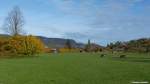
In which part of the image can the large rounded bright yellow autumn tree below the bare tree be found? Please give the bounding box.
[10,35,44,55]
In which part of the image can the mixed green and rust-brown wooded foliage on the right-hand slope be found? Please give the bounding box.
[107,38,150,52]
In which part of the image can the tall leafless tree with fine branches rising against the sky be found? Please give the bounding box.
[3,6,24,36]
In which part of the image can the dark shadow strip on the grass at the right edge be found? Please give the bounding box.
[113,57,150,63]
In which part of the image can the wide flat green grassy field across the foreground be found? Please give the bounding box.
[0,53,150,84]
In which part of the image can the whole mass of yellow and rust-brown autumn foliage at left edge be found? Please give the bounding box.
[0,35,44,55]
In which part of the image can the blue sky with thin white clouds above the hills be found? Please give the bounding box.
[0,0,150,45]
